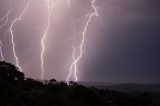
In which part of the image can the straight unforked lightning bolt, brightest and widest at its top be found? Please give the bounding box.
[41,0,54,79]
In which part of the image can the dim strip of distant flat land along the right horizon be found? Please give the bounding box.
[78,82,160,93]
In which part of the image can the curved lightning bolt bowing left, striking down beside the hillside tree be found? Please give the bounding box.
[9,0,33,72]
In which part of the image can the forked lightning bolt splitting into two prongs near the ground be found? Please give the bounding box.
[66,0,98,84]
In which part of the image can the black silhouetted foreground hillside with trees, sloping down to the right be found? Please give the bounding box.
[0,62,160,106]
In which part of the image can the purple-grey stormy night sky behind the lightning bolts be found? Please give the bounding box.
[0,0,160,83]
